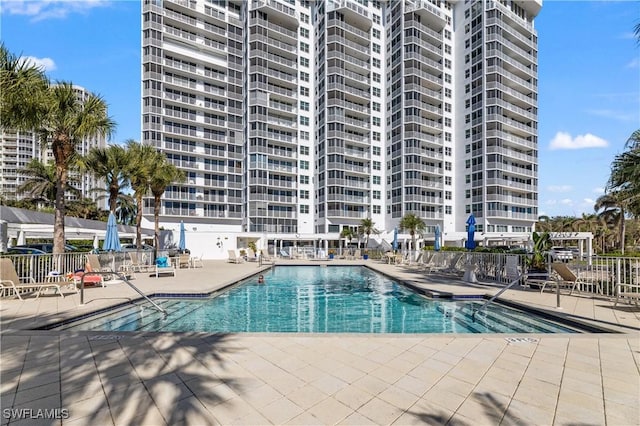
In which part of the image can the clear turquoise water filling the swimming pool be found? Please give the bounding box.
[57,266,578,333]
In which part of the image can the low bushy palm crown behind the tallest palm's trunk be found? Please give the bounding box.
[16,158,80,207]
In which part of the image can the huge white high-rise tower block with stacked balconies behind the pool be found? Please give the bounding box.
[142,0,542,246]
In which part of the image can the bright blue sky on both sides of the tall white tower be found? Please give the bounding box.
[0,0,640,216]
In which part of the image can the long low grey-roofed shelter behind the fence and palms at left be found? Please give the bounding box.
[0,206,154,252]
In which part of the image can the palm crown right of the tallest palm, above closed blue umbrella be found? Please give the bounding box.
[84,145,130,214]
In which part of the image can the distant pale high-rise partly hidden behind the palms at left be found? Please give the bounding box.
[0,86,106,205]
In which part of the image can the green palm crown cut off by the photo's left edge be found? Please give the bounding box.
[0,43,49,130]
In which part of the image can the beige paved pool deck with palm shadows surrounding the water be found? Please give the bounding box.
[0,260,640,426]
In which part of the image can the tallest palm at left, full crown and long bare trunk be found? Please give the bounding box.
[38,82,115,254]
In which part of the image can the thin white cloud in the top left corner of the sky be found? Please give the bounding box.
[0,0,111,22]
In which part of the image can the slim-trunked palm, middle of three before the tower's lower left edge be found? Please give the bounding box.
[126,139,158,248]
